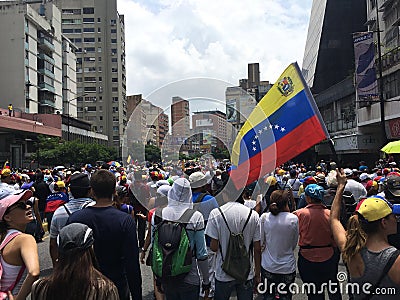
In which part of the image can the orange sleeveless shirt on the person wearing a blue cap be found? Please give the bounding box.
[293,203,336,262]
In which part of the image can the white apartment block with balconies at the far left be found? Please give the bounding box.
[0,1,77,117]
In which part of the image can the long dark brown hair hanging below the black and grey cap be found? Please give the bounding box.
[37,247,112,300]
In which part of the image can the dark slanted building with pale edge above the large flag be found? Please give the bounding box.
[302,0,366,94]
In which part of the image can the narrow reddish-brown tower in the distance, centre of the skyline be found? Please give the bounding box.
[171,97,190,139]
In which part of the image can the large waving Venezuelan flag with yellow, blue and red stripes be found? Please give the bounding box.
[230,63,329,189]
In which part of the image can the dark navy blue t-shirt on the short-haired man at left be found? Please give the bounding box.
[67,206,142,299]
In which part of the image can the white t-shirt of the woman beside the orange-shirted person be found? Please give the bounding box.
[260,212,299,274]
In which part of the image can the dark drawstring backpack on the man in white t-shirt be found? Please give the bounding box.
[218,207,253,282]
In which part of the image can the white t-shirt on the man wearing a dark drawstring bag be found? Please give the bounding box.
[206,202,260,282]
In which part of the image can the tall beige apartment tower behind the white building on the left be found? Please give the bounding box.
[53,0,127,147]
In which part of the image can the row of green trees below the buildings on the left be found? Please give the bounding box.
[31,136,118,166]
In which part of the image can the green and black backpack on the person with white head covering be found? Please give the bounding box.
[151,208,195,283]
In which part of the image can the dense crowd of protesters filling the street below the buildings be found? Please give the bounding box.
[0,159,400,300]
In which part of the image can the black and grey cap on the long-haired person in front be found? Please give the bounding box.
[57,223,94,253]
